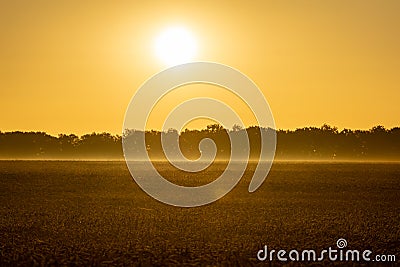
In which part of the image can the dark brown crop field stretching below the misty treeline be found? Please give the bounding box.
[0,161,400,266]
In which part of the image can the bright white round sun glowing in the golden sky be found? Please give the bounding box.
[154,27,197,66]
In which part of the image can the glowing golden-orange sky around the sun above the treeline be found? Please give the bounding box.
[0,0,400,134]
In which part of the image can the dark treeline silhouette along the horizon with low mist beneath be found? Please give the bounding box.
[0,124,400,160]
